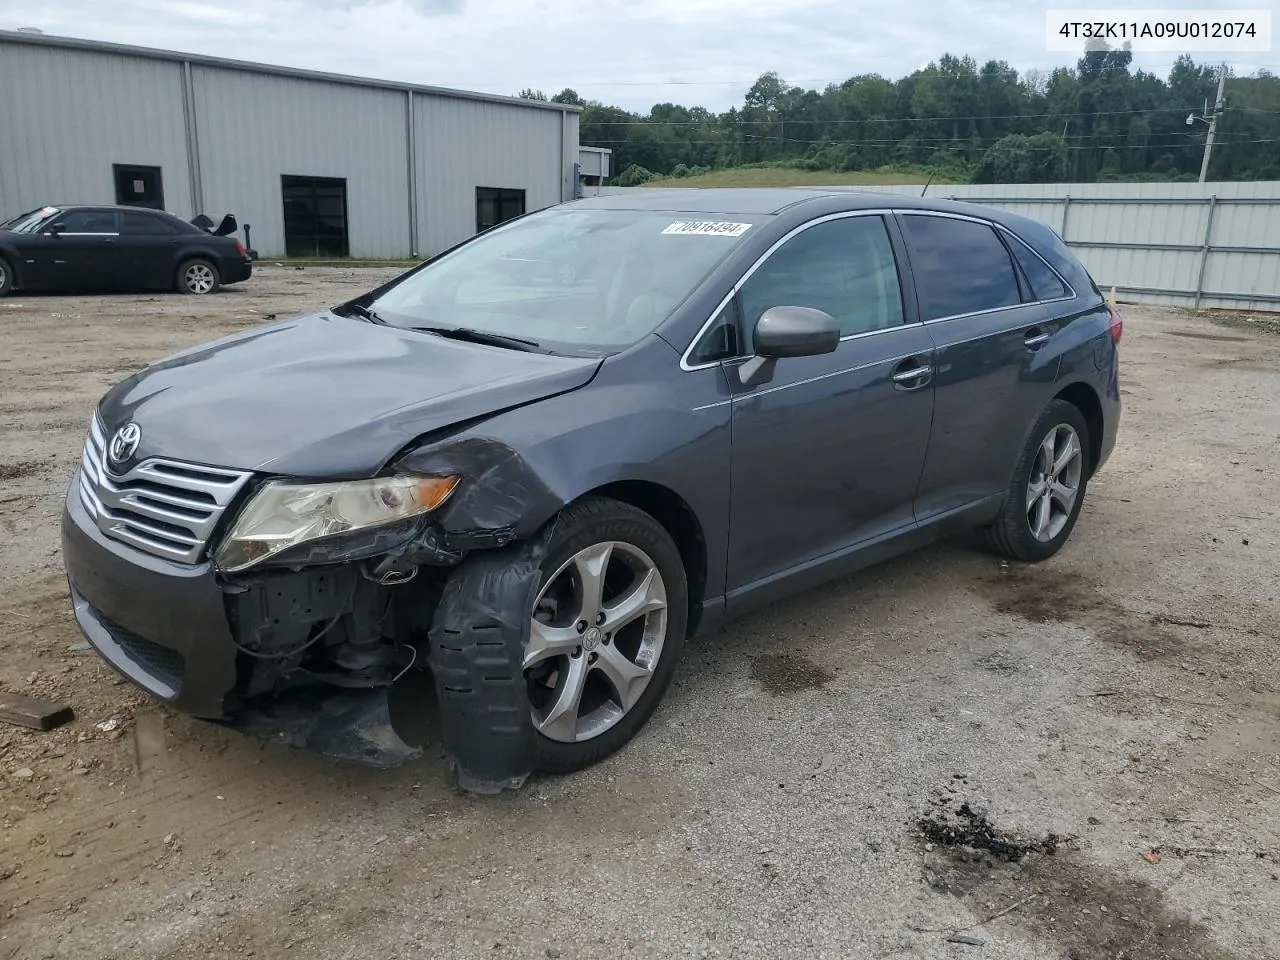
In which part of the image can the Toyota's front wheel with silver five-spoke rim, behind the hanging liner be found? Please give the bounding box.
[524,498,689,772]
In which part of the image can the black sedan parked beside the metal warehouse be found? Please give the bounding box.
[0,206,253,297]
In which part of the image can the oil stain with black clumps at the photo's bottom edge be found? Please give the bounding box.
[916,799,1230,960]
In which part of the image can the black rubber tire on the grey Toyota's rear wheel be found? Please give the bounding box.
[980,399,1093,563]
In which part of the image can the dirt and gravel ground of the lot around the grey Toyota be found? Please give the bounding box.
[0,266,1280,960]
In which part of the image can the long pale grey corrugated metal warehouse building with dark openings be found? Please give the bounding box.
[0,31,580,257]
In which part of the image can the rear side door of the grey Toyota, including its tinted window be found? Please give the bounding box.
[897,211,1057,524]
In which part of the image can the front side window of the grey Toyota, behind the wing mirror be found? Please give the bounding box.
[739,216,902,337]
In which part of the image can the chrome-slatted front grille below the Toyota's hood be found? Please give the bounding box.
[79,416,250,563]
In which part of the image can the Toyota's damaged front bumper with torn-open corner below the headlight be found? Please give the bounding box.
[61,480,425,767]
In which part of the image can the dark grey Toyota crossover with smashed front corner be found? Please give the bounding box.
[63,189,1121,790]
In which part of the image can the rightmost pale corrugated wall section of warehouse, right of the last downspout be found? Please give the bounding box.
[413,96,577,256]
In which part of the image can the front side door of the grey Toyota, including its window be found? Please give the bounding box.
[726,214,933,596]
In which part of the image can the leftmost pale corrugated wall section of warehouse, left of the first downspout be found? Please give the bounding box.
[0,41,191,218]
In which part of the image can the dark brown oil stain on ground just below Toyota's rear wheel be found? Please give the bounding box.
[977,567,1184,659]
